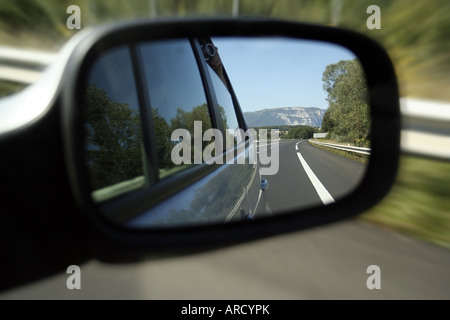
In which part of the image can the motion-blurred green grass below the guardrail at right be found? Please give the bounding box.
[361,156,450,248]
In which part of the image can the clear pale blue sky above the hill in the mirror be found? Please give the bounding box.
[212,38,355,112]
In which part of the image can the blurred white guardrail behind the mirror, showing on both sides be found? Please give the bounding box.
[0,46,450,159]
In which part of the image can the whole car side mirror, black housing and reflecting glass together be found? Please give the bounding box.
[62,19,400,260]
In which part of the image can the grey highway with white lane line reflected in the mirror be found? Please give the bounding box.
[260,140,366,213]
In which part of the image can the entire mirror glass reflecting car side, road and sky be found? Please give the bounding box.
[82,37,371,228]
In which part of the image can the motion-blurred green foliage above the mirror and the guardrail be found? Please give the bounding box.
[0,0,450,100]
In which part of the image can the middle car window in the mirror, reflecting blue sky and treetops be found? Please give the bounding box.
[139,39,212,179]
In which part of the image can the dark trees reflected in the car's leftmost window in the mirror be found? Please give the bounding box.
[85,85,143,190]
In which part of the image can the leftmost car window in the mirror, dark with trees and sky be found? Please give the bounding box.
[84,46,146,201]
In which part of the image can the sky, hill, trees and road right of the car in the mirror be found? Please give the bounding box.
[213,38,370,213]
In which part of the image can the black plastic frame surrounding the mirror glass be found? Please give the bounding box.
[61,18,401,262]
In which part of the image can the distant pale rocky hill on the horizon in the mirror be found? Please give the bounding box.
[244,107,326,127]
